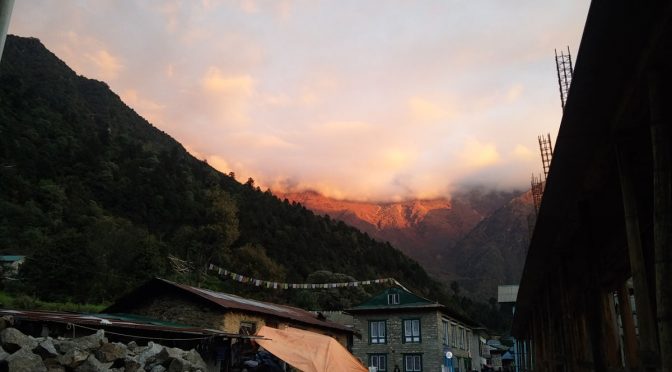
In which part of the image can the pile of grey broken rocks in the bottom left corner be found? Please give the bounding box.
[0,328,207,372]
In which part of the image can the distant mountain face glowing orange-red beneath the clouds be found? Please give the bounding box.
[275,187,532,297]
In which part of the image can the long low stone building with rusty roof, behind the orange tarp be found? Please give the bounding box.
[104,278,353,347]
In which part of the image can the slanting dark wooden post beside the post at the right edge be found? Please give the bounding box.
[617,148,658,370]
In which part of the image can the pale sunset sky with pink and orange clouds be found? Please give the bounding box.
[9,0,589,201]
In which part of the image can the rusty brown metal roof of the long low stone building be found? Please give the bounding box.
[104,278,353,332]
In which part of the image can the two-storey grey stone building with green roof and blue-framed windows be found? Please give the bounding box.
[347,288,482,372]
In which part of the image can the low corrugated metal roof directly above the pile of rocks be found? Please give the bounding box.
[0,309,250,338]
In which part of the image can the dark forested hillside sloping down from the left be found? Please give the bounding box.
[0,36,510,332]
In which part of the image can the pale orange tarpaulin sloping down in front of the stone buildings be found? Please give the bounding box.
[255,326,368,372]
